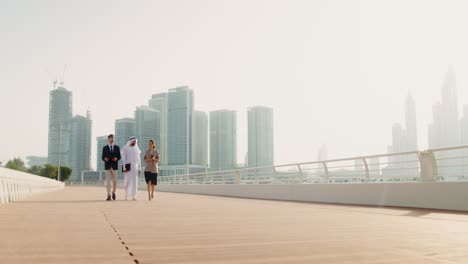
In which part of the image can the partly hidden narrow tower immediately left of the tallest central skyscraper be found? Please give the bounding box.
[148,93,167,165]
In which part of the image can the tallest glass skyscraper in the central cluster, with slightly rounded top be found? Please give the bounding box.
[167,86,194,165]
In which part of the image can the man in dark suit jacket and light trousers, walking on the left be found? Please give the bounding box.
[102,134,120,201]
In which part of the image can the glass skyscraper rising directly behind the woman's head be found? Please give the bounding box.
[135,106,160,160]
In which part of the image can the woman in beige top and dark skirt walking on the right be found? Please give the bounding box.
[144,139,159,201]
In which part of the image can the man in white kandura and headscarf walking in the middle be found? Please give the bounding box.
[121,137,141,201]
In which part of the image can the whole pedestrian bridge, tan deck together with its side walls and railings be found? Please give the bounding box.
[0,146,468,263]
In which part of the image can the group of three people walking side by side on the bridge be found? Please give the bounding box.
[102,134,160,201]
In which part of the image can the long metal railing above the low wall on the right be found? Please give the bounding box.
[77,145,468,188]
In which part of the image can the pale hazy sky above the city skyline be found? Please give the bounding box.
[0,0,468,168]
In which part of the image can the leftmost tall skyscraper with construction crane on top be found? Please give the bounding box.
[48,86,72,166]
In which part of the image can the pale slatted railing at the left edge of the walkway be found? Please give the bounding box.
[0,167,64,204]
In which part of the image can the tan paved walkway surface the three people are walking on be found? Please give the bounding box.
[0,187,468,264]
